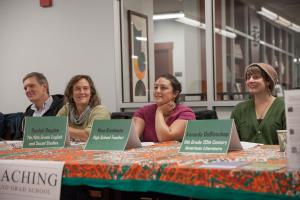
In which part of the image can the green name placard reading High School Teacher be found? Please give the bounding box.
[85,119,141,151]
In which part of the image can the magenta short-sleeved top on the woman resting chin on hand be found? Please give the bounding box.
[134,104,196,142]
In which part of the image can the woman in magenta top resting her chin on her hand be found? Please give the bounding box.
[133,74,196,142]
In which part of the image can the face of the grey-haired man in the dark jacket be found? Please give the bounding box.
[23,76,48,104]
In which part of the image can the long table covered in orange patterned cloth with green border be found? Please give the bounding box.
[0,142,300,200]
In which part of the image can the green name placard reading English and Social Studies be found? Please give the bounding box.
[23,116,68,148]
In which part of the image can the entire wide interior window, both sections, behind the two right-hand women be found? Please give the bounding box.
[120,0,300,109]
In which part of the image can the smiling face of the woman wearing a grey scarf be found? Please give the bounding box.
[72,78,91,107]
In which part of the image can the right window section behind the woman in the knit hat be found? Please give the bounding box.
[214,0,296,101]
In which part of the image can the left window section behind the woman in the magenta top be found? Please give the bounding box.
[122,0,207,102]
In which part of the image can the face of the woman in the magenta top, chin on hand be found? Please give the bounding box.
[153,78,176,106]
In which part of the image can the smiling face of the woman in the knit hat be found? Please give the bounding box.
[246,67,270,95]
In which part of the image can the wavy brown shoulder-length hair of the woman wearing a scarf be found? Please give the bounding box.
[64,74,101,108]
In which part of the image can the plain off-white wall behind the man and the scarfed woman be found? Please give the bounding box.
[0,0,119,113]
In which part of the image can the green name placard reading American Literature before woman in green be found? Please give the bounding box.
[179,119,242,153]
